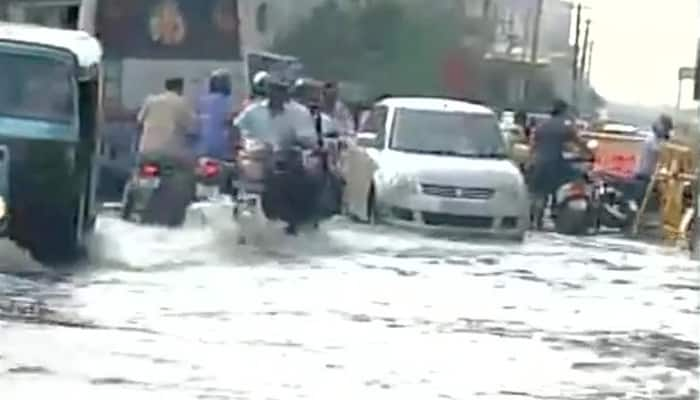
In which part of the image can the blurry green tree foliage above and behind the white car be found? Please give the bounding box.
[274,0,462,99]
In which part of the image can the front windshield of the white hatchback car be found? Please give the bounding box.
[391,109,507,158]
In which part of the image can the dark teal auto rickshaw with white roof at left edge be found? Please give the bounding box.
[0,23,102,262]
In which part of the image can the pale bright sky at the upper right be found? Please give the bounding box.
[582,0,700,107]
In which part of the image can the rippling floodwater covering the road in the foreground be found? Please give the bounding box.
[0,206,700,400]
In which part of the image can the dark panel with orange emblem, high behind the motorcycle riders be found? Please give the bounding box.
[96,0,241,60]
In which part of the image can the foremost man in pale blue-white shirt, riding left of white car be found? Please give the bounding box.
[234,76,320,234]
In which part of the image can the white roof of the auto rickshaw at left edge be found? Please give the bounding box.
[0,22,102,67]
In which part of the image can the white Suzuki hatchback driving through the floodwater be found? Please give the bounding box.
[343,98,530,240]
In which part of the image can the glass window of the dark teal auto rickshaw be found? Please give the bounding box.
[0,50,76,125]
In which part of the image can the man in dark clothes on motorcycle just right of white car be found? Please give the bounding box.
[529,100,592,229]
